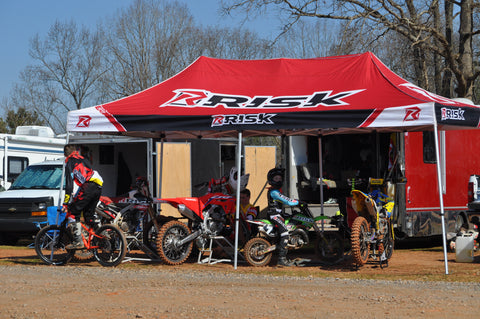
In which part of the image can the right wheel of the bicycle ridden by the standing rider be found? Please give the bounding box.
[92,225,127,267]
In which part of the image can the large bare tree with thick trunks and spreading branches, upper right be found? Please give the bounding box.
[222,0,480,98]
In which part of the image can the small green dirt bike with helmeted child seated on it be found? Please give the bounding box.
[244,203,343,267]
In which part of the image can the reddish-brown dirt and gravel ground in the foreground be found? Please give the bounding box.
[0,246,480,318]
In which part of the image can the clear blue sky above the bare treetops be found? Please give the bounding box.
[0,0,276,99]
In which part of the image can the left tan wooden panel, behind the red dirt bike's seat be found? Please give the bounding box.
[156,142,192,217]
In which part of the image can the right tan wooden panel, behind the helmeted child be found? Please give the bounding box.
[245,146,276,210]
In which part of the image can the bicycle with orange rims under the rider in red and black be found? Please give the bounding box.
[35,208,127,266]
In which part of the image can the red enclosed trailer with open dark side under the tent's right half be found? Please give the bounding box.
[289,130,480,239]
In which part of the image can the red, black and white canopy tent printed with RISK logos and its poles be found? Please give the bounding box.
[67,52,480,272]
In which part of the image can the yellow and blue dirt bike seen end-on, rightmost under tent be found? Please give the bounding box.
[351,179,395,268]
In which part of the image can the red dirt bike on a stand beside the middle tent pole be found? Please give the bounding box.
[157,170,249,265]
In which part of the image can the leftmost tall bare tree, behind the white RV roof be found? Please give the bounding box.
[5,21,104,132]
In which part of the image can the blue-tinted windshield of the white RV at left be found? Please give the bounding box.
[10,165,62,189]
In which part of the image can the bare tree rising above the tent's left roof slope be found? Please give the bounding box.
[99,0,198,99]
